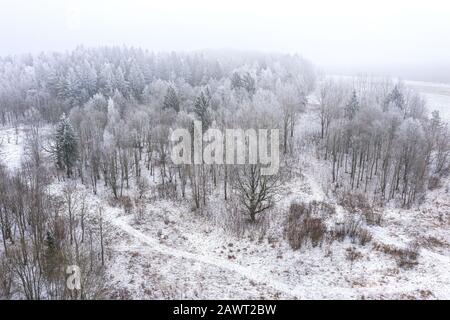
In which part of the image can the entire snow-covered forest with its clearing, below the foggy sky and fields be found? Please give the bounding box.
[0,46,450,299]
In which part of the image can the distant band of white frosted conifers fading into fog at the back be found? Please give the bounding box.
[0,47,315,124]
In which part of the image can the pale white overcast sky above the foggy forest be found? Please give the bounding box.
[0,0,450,80]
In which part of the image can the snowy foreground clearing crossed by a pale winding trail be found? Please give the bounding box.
[101,151,450,299]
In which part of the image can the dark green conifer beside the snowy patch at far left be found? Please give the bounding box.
[55,114,77,177]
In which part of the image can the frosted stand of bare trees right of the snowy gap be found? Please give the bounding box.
[319,78,450,206]
